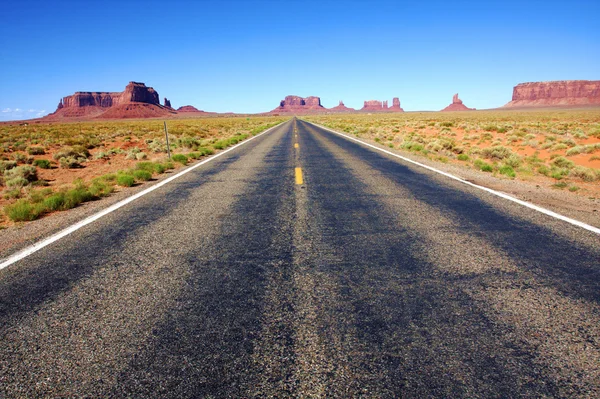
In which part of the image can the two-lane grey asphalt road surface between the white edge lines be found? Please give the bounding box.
[0,120,600,398]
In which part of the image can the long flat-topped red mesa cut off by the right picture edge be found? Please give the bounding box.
[504,80,600,108]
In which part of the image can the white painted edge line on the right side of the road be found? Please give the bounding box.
[305,121,600,234]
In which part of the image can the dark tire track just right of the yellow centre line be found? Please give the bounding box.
[302,122,557,397]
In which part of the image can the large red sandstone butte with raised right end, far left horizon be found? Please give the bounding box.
[46,82,175,119]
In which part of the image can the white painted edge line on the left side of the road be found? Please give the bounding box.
[0,121,288,270]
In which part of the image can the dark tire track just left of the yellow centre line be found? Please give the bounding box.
[107,126,293,398]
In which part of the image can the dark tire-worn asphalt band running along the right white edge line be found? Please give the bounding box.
[304,122,600,302]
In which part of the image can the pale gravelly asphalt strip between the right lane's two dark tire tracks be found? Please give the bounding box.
[308,122,600,397]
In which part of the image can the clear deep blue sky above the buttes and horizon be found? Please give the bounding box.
[0,0,600,120]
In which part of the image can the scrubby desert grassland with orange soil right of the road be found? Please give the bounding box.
[306,109,600,194]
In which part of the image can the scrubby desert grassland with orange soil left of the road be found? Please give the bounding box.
[0,117,286,227]
